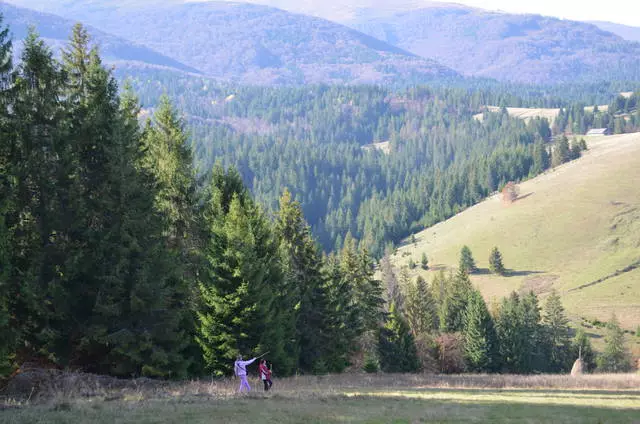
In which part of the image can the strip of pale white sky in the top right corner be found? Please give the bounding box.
[452,0,640,27]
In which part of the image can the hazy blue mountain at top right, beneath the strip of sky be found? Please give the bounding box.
[351,4,640,83]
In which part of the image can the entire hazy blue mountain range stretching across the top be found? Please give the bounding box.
[5,0,640,84]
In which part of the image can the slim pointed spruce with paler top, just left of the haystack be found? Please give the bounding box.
[542,290,571,372]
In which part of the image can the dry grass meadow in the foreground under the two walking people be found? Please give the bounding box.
[0,375,640,424]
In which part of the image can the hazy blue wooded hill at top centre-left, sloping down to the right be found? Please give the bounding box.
[2,1,456,84]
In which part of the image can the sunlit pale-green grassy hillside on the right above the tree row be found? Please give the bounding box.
[393,133,640,330]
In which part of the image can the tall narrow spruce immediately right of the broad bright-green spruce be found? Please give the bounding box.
[276,190,329,372]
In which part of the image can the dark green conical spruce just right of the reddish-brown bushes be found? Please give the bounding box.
[462,290,499,372]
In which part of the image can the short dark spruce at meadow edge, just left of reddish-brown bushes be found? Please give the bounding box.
[378,303,420,372]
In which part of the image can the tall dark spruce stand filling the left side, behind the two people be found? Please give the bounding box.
[0,22,390,378]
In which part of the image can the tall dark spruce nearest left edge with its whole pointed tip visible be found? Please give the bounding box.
[2,29,68,362]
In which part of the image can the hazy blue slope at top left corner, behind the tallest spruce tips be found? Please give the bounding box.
[0,3,197,72]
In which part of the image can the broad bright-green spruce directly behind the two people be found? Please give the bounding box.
[197,166,288,375]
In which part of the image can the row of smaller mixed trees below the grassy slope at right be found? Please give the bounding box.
[378,246,631,373]
